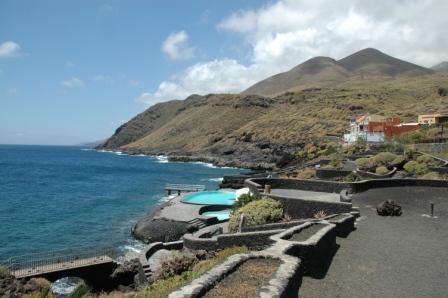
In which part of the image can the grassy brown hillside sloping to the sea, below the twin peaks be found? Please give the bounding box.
[102,73,448,167]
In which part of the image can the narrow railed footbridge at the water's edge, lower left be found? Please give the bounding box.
[4,248,117,277]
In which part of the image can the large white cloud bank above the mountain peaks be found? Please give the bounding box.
[139,0,448,104]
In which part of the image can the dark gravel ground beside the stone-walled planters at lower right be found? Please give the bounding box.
[299,187,448,297]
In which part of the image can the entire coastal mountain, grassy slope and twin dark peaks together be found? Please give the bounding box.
[97,49,448,168]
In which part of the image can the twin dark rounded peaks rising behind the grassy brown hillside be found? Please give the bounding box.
[242,48,432,95]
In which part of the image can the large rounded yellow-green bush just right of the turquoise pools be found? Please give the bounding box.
[229,198,283,232]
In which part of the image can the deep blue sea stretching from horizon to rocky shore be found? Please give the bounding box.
[0,145,241,260]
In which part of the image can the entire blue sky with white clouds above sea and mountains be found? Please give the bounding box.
[0,0,448,145]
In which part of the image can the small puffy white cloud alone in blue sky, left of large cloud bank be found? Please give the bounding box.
[162,30,195,60]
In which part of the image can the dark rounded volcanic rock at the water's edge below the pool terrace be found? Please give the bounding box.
[132,216,190,243]
